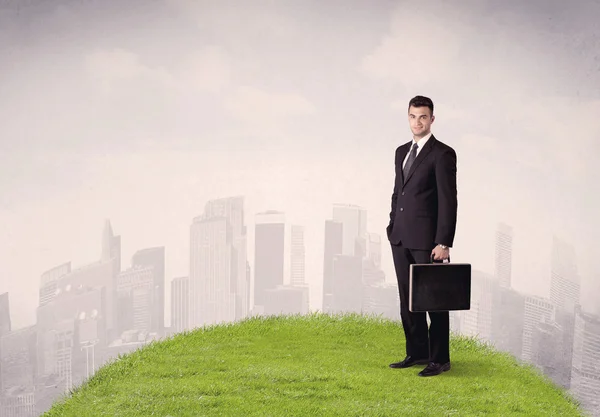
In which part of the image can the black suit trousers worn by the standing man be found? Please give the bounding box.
[391,243,450,363]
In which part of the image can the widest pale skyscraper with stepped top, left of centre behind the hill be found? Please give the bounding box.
[189,197,248,328]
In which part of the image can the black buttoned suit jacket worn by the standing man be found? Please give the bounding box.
[387,135,458,250]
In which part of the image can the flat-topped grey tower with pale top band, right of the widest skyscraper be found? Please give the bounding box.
[254,210,285,308]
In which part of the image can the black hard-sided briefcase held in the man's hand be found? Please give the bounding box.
[408,255,471,313]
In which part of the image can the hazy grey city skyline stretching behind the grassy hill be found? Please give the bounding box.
[0,200,600,412]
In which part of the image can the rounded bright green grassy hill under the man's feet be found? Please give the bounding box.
[44,314,582,417]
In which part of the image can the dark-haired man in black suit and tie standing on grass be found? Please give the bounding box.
[386,96,458,376]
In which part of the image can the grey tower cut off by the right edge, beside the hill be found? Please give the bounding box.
[571,306,600,411]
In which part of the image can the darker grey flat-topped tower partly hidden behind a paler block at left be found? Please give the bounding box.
[131,246,165,334]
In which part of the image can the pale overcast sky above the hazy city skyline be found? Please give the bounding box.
[0,0,600,327]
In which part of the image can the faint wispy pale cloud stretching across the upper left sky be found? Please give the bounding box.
[85,45,315,133]
